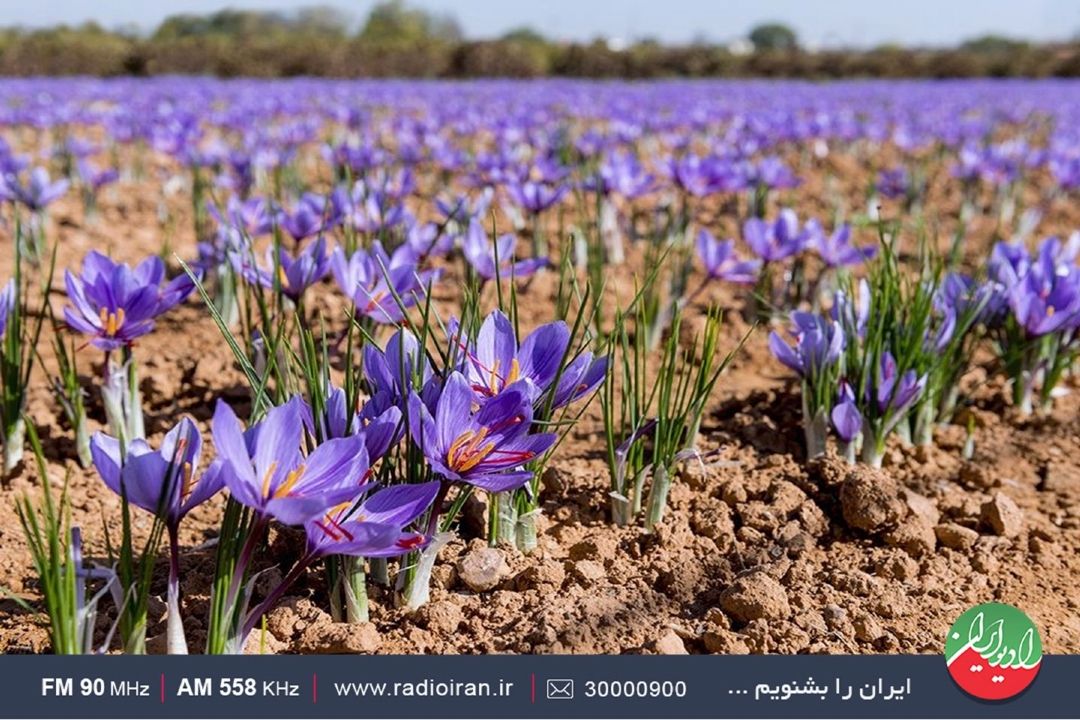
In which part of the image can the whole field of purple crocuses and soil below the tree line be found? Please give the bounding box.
[0,78,1080,653]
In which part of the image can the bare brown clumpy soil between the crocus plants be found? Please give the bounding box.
[0,144,1080,653]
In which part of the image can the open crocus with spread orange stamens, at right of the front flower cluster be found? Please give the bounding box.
[408,372,555,492]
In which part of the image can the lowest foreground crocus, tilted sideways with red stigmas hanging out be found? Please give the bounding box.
[305,480,440,558]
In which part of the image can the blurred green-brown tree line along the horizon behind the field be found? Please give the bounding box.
[0,0,1080,80]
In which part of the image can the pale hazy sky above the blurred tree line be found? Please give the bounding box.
[0,0,1080,47]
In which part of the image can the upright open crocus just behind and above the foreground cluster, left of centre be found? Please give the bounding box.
[329,241,438,324]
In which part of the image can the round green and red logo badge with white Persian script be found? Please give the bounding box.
[945,602,1042,701]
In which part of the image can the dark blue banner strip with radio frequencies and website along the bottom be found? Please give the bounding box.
[0,655,1080,720]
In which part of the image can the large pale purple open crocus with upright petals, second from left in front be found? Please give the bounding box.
[212,397,368,525]
